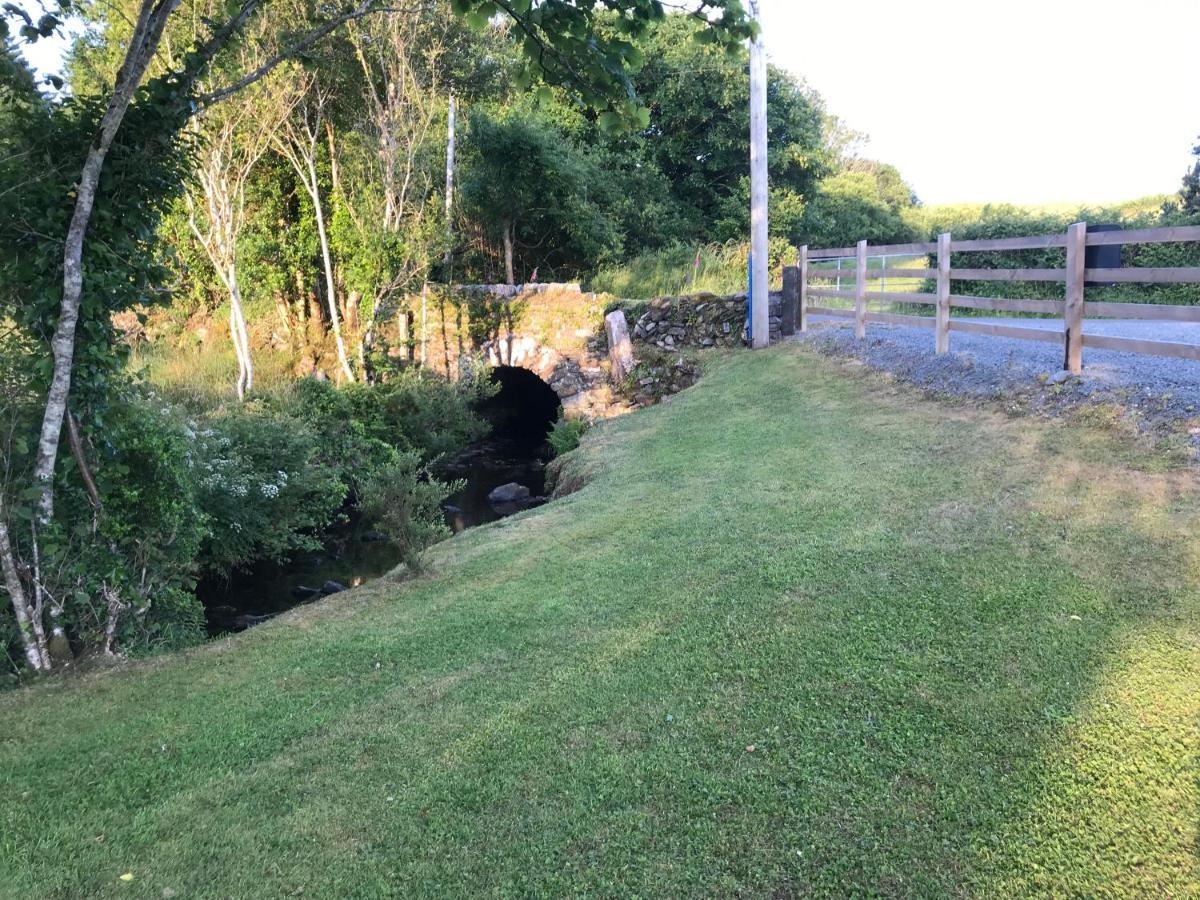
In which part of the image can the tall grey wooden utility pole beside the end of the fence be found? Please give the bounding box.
[750,0,770,349]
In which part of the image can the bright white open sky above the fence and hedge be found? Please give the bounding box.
[761,0,1200,204]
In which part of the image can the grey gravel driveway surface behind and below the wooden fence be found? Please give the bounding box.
[794,317,1200,456]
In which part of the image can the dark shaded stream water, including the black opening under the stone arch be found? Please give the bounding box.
[197,367,558,636]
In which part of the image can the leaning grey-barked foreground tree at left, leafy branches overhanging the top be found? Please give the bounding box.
[0,0,752,670]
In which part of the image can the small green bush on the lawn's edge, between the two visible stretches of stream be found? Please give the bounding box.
[362,452,463,572]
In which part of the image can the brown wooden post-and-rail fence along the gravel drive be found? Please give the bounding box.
[785,222,1200,374]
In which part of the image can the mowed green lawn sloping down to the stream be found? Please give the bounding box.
[0,346,1200,898]
